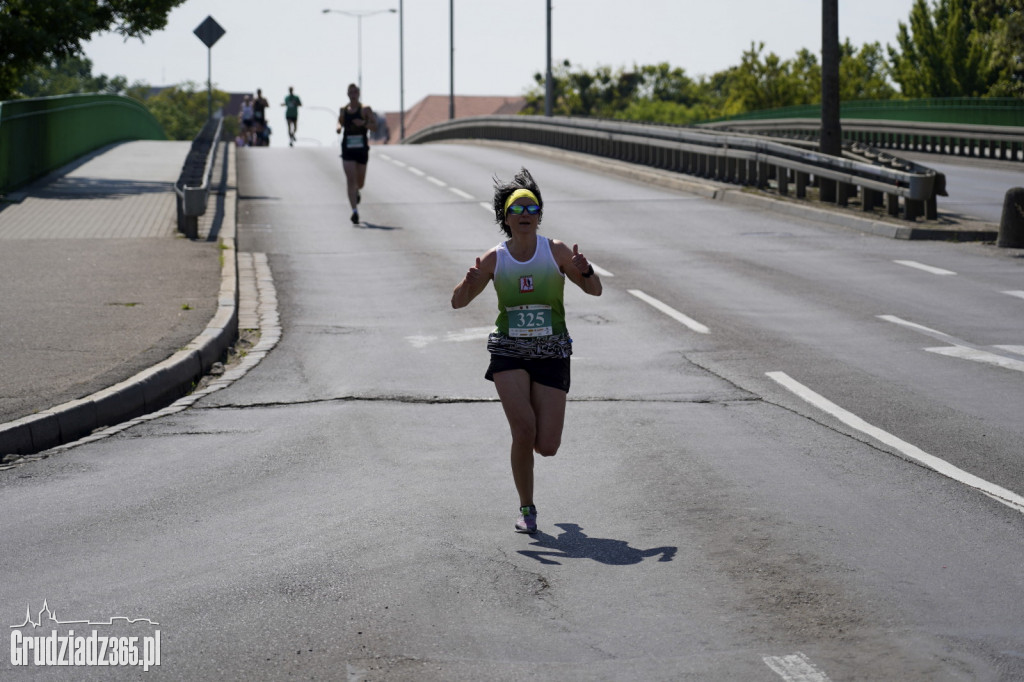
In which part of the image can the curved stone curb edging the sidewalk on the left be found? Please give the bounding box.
[0,142,239,458]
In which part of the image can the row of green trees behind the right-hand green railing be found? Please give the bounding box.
[523,0,1024,124]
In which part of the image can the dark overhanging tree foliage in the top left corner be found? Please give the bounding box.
[0,0,184,100]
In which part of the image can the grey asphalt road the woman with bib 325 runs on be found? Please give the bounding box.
[0,144,1024,681]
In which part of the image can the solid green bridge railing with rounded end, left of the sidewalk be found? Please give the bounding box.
[0,94,166,195]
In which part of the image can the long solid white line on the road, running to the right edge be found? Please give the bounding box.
[766,372,1024,513]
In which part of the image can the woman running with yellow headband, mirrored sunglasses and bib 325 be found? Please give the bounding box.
[452,168,601,532]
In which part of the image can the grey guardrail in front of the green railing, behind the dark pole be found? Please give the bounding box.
[698,118,1024,161]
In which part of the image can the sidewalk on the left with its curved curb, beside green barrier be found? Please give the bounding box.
[0,141,238,458]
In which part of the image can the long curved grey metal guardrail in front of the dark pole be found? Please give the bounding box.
[404,116,944,220]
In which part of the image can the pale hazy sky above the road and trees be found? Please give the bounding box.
[85,0,913,146]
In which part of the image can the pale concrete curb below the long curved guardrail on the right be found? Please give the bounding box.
[450,139,998,242]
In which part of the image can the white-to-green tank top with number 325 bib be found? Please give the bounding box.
[495,235,566,340]
